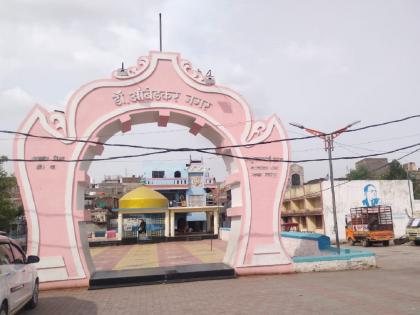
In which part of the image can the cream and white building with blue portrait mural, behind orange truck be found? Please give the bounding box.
[281,180,418,241]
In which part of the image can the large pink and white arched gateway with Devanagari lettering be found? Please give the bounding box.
[14,52,293,285]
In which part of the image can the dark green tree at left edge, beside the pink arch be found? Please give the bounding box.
[0,156,18,231]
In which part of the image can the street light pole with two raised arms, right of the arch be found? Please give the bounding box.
[290,120,360,255]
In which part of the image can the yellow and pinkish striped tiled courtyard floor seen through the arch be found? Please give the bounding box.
[90,240,227,270]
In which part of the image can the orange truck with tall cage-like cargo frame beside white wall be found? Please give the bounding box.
[346,206,394,247]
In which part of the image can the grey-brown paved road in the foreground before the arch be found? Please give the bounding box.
[20,245,420,315]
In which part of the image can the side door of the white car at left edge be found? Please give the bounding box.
[0,243,24,310]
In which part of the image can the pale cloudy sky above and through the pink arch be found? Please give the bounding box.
[0,0,420,181]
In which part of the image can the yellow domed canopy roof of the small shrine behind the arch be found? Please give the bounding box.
[119,186,168,210]
